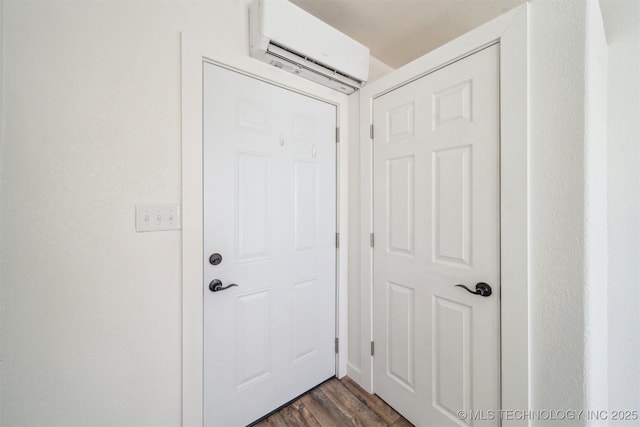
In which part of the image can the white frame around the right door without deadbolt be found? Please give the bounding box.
[356,4,530,425]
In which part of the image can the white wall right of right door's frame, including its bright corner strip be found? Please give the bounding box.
[529,0,607,418]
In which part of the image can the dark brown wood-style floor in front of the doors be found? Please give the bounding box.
[255,377,413,427]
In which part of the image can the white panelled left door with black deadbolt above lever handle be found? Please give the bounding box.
[203,64,336,427]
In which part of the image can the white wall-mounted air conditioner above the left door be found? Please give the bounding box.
[249,0,369,94]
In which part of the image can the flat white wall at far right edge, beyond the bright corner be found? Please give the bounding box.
[600,0,640,409]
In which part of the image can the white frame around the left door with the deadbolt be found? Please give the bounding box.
[181,32,349,427]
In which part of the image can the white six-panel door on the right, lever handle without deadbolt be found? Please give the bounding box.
[373,45,500,426]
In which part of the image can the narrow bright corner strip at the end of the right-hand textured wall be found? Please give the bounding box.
[584,2,608,410]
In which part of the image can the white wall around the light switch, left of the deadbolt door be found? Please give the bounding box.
[0,0,247,426]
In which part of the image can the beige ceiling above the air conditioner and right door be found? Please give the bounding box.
[290,0,526,68]
